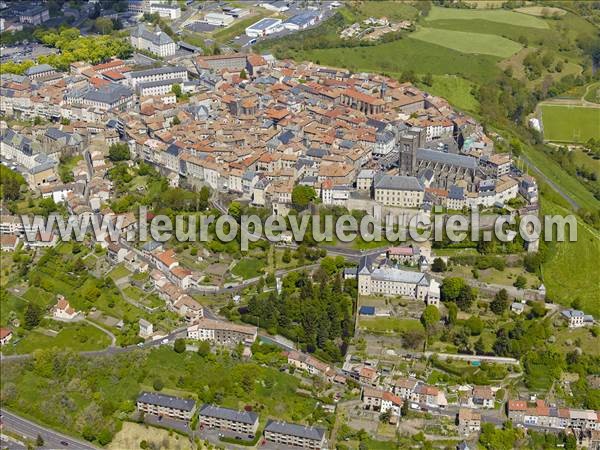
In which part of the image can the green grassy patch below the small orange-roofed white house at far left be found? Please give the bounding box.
[8,323,110,354]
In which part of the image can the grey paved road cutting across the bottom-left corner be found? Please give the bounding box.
[0,409,98,450]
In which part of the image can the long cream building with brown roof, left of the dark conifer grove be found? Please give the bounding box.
[187,319,258,345]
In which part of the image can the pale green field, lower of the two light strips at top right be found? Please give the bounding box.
[410,28,522,58]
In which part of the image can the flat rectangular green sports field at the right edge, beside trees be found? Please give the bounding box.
[541,104,600,142]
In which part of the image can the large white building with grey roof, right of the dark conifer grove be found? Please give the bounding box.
[358,257,440,306]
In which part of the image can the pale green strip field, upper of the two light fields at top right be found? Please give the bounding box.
[426,6,548,29]
